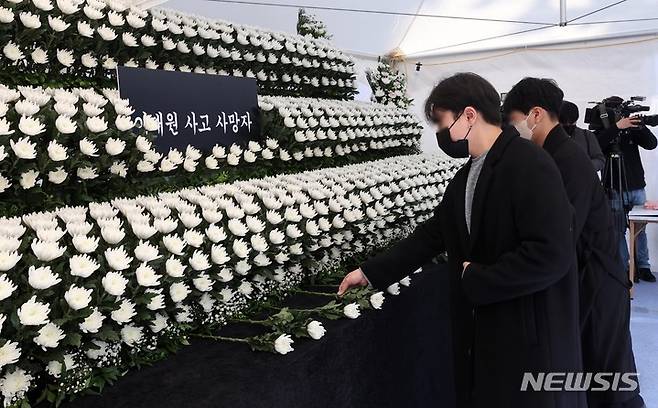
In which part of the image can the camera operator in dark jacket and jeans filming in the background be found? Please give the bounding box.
[596,96,658,282]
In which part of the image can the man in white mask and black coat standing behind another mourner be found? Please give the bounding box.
[503,78,644,408]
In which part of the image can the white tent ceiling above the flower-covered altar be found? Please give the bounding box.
[160,0,658,58]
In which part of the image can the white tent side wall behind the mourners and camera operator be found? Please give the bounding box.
[398,36,658,270]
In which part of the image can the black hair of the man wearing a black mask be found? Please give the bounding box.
[425,72,501,126]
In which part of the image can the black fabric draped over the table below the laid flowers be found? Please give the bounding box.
[63,265,455,408]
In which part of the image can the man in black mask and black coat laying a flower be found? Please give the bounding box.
[339,73,586,408]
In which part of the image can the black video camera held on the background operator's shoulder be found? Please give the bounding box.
[585,96,658,131]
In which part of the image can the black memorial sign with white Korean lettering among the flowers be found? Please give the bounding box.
[117,67,260,153]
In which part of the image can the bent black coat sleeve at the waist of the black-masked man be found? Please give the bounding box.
[462,154,575,305]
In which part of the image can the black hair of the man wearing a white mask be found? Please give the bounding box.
[503,78,564,119]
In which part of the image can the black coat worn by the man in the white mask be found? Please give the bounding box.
[544,125,639,408]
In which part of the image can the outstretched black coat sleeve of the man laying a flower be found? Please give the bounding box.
[361,200,445,290]
